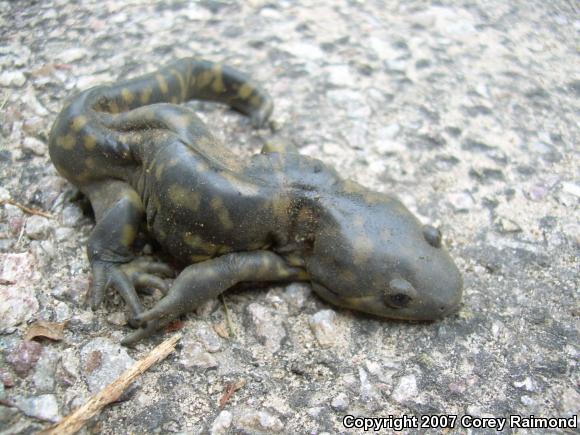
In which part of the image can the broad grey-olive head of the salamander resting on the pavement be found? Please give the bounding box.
[306,192,463,320]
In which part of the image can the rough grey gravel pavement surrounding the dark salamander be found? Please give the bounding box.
[0,0,580,434]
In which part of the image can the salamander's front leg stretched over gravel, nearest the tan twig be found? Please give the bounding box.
[122,251,304,345]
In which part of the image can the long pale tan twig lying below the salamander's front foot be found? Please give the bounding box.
[40,334,181,435]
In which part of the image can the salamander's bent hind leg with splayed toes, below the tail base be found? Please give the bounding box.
[85,180,172,324]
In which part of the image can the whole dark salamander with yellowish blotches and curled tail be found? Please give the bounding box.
[50,58,463,344]
